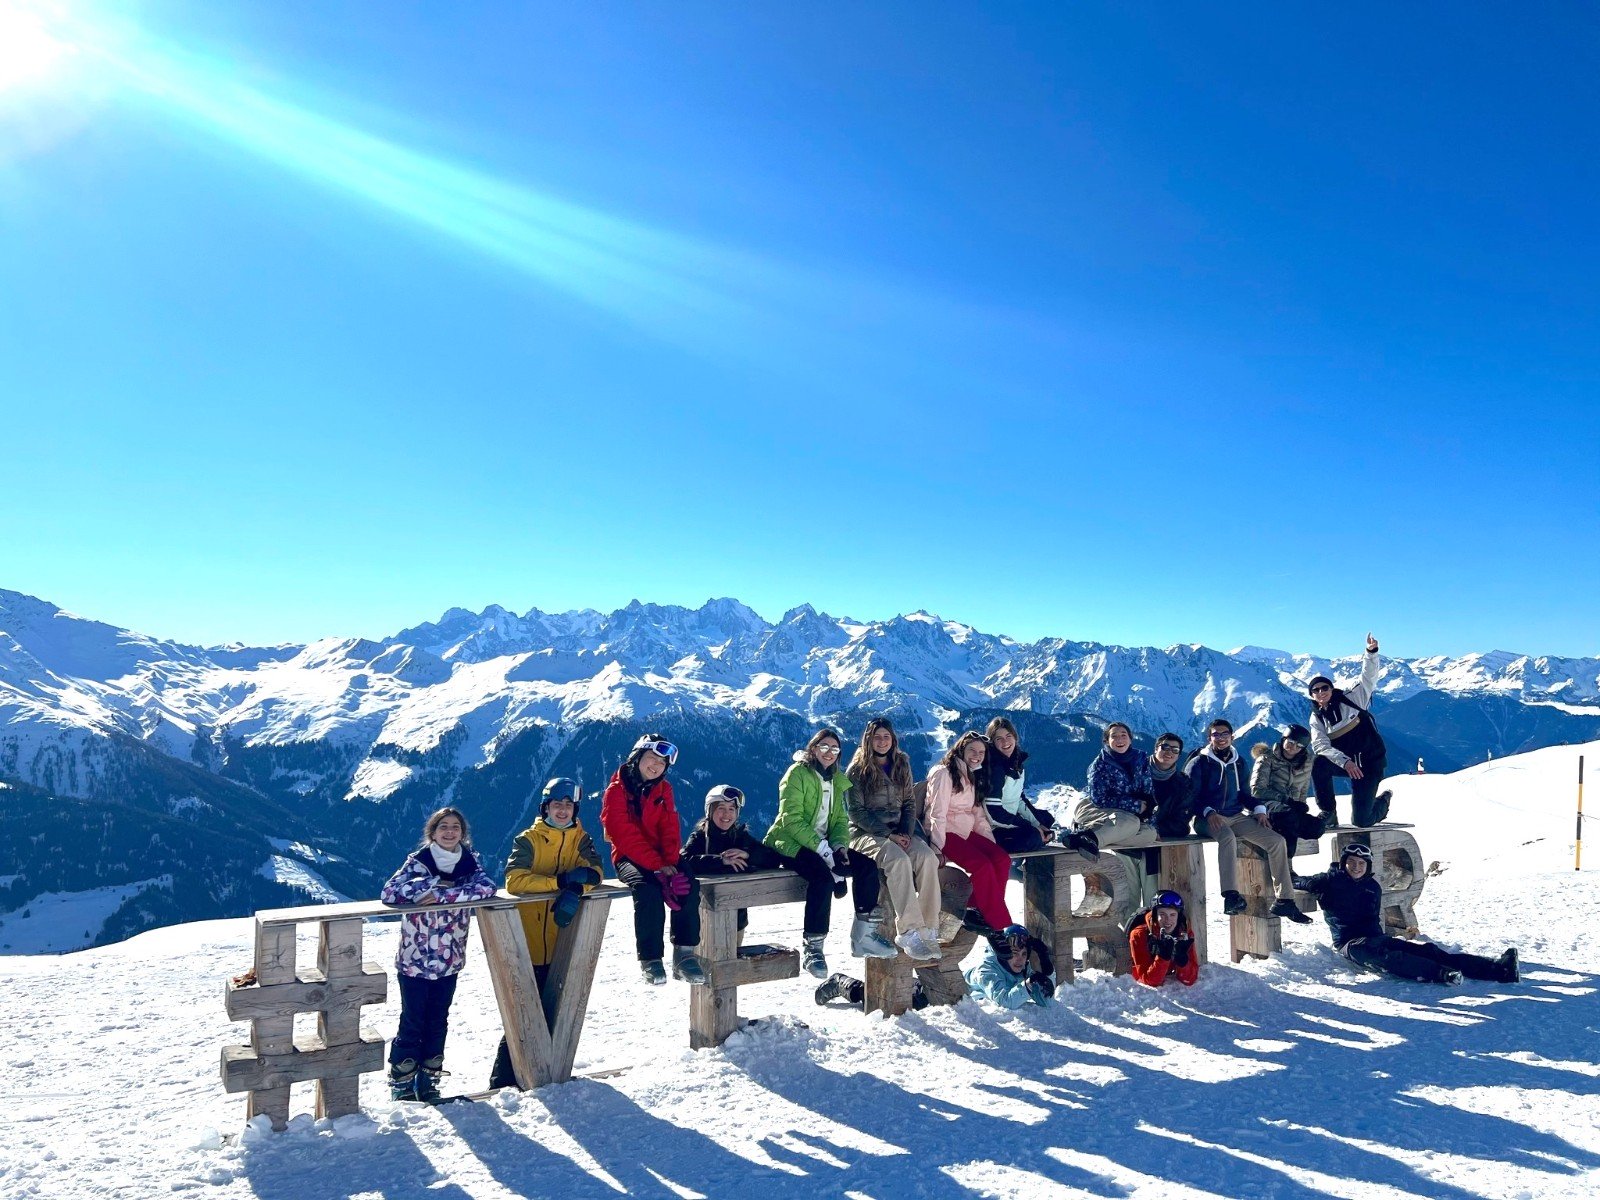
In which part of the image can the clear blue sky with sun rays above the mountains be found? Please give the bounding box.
[0,0,1600,656]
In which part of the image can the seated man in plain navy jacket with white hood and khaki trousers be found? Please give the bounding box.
[1184,717,1310,925]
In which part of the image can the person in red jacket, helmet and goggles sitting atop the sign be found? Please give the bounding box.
[600,733,706,986]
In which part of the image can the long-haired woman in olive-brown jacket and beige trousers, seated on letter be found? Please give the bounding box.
[845,717,942,962]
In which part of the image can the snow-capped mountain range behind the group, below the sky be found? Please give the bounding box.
[0,590,1600,953]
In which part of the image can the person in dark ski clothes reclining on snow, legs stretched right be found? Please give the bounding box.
[1304,842,1520,984]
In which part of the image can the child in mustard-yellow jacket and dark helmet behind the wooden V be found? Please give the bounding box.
[490,778,600,1088]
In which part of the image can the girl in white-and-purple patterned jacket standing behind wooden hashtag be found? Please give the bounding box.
[382,808,494,1101]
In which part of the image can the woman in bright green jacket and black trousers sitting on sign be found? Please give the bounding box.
[763,728,850,979]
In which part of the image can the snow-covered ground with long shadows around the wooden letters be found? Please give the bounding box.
[0,744,1600,1200]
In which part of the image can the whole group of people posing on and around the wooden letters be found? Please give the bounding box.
[368,635,1517,1101]
